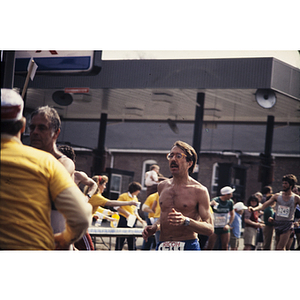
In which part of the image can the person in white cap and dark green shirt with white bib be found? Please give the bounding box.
[207,186,235,250]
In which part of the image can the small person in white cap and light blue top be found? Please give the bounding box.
[230,202,248,250]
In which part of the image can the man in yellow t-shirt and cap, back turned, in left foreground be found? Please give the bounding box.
[0,89,92,250]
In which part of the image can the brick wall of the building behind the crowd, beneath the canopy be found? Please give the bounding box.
[76,152,300,202]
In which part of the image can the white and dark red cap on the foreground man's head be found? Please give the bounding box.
[1,89,24,122]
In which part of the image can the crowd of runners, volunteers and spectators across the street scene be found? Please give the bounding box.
[0,89,300,251]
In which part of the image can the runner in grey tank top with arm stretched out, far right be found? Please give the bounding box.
[248,174,300,250]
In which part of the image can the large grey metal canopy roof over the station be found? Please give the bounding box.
[14,58,300,125]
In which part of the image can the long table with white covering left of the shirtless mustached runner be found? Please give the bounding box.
[88,226,143,250]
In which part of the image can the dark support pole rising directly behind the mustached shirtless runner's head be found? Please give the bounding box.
[191,93,205,180]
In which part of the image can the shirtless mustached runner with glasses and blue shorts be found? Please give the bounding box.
[143,141,214,250]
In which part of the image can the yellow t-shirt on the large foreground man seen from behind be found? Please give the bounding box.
[0,135,75,250]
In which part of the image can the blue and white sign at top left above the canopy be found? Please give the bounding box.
[15,50,102,74]
